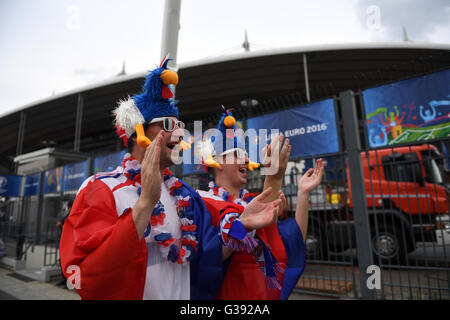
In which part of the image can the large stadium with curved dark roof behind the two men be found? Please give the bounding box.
[0,42,450,298]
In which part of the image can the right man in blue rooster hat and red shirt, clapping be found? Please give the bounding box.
[197,108,324,300]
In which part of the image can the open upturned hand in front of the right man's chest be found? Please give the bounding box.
[239,188,283,230]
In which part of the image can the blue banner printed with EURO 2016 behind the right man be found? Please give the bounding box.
[247,99,339,161]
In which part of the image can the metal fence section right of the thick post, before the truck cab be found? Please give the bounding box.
[363,141,450,299]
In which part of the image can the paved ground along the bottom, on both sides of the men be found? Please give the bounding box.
[0,265,450,300]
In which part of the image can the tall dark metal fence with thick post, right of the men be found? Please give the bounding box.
[183,92,450,299]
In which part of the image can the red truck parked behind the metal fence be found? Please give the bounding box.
[306,144,450,264]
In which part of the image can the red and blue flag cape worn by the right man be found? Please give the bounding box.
[197,189,305,300]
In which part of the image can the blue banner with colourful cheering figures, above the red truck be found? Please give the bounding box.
[363,70,450,148]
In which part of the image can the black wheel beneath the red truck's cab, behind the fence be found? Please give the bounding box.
[371,225,408,265]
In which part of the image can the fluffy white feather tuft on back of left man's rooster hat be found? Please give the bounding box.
[113,97,145,138]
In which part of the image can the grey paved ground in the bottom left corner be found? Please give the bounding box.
[0,267,80,300]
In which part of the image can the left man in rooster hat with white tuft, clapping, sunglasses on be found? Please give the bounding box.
[60,58,281,299]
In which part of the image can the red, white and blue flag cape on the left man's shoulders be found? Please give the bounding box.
[60,156,223,300]
